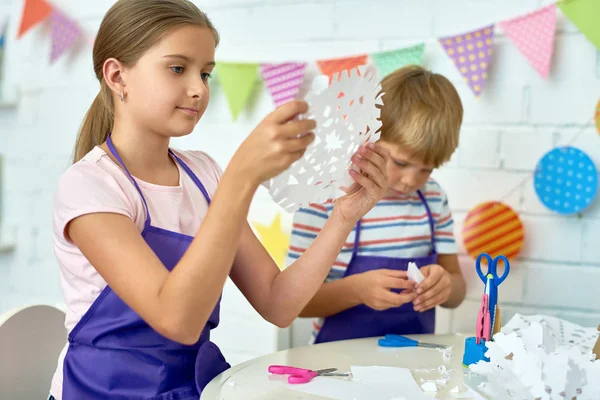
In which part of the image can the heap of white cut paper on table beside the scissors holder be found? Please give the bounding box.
[470,314,600,400]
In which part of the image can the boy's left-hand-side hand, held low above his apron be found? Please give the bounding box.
[351,269,416,311]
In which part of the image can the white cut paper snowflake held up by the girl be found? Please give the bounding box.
[265,68,383,212]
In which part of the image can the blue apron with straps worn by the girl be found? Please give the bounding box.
[62,135,230,400]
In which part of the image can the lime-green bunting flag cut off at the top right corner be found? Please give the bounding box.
[557,0,600,50]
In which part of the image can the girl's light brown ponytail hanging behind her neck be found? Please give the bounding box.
[73,80,114,163]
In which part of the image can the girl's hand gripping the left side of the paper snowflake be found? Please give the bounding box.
[230,100,316,186]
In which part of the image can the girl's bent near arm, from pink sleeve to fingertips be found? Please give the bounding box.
[65,101,315,344]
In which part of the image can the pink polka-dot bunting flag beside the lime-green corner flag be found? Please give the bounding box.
[498,4,556,78]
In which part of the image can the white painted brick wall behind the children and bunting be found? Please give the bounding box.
[0,0,600,363]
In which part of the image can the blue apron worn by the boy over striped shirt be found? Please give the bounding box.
[315,191,437,343]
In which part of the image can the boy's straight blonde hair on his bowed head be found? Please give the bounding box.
[381,65,463,168]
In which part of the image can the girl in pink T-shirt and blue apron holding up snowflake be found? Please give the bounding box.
[51,0,388,400]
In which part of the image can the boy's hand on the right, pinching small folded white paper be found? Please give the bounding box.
[413,264,452,312]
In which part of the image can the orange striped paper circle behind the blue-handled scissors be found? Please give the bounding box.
[462,201,524,260]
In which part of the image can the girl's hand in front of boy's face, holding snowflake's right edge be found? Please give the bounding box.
[334,143,390,225]
